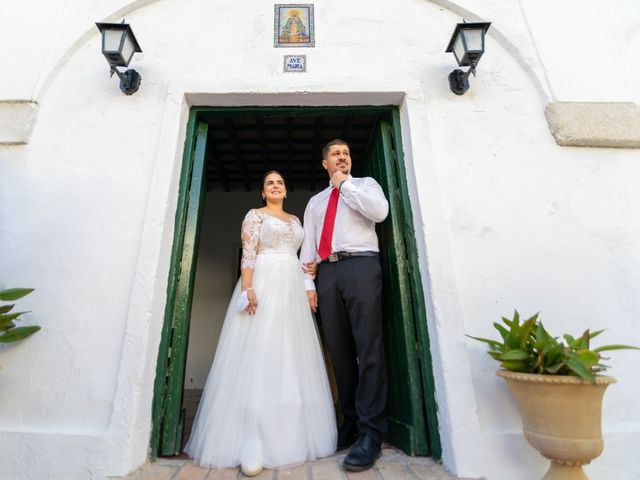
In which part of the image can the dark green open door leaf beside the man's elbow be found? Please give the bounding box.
[367,120,430,455]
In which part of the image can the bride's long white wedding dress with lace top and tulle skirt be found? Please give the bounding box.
[185,210,336,468]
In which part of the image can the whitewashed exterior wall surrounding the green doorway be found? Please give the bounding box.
[0,0,640,480]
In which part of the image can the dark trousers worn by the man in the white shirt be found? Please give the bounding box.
[316,257,387,442]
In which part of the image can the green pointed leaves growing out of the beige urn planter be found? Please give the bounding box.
[467,310,640,381]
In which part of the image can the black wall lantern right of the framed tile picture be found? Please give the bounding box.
[447,22,491,95]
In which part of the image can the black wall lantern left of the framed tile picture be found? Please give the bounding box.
[96,20,142,95]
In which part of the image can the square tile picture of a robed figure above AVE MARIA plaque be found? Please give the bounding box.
[273,3,315,47]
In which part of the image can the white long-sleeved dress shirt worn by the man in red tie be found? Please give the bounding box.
[300,175,389,290]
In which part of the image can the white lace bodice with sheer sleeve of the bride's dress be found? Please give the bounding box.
[241,210,304,268]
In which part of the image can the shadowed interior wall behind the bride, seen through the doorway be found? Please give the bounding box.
[184,190,312,389]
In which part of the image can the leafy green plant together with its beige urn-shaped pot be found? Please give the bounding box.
[467,310,638,480]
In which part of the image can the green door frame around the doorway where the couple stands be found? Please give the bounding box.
[150,106,442,460]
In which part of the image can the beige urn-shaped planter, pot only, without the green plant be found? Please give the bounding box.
[497,370,616,480]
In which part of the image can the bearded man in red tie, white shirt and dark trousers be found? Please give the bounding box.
[300,139,389,471]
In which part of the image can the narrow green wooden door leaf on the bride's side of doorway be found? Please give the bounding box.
[151,120,208,458]
